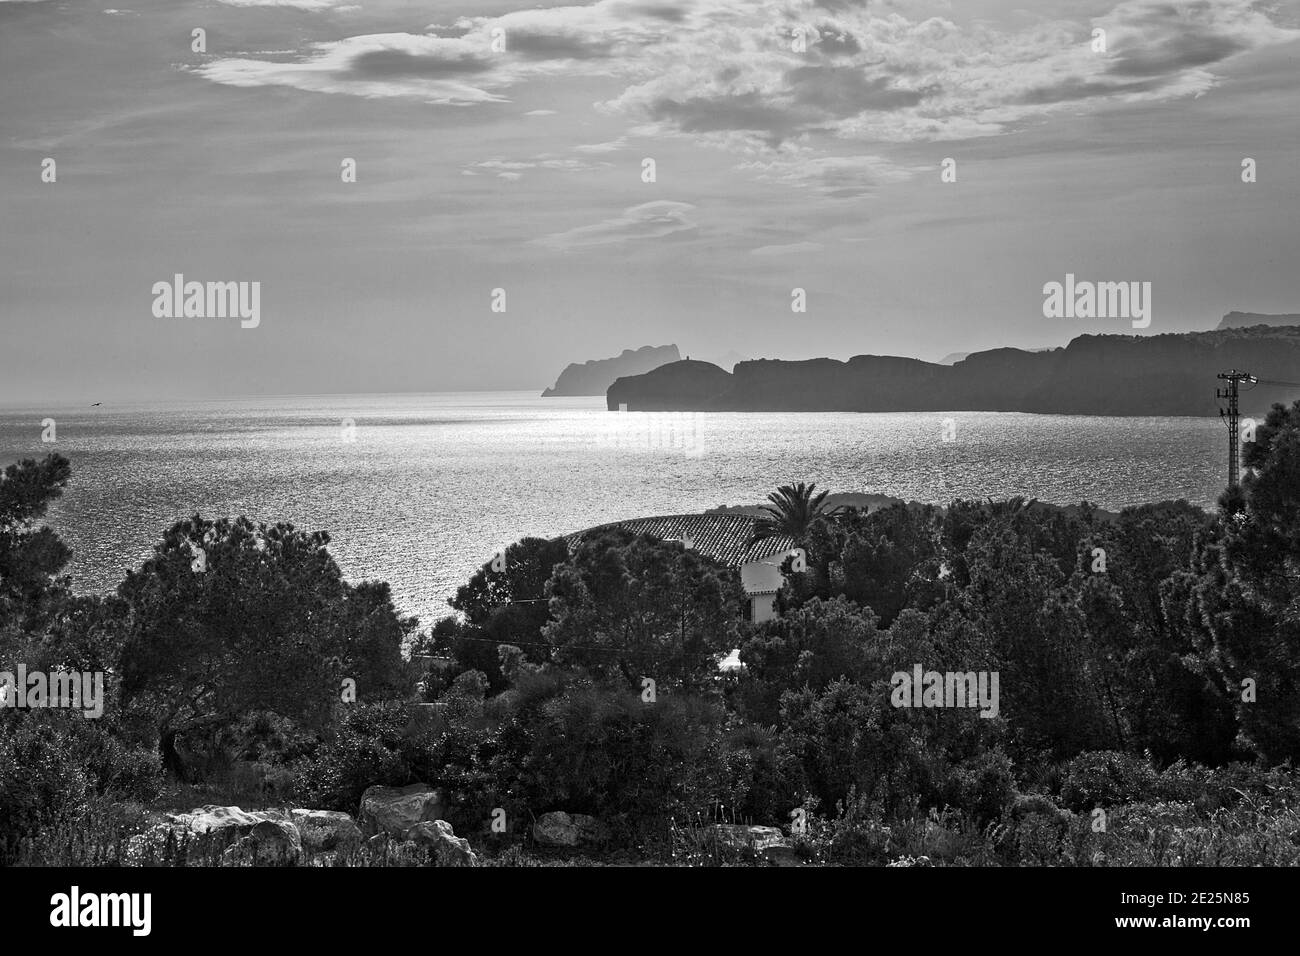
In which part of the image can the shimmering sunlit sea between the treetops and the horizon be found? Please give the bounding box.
[0,392,1227,623]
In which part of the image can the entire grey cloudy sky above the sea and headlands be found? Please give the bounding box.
[0,0,1300,403]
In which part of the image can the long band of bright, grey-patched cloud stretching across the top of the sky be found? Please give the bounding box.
[191,0,1300,178]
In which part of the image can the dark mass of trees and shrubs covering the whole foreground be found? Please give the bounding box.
[0,403,1300,866]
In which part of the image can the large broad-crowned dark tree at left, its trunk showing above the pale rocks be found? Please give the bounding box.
[118,515,410,777]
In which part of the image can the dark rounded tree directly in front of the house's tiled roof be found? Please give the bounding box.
[542,529,744,689]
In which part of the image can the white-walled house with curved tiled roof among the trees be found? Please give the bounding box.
[564,514,796,622]
